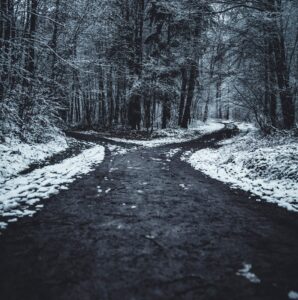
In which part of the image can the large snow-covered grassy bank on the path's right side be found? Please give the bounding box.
[186,131,298,212]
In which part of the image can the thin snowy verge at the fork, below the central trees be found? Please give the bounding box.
[102,120,225,148]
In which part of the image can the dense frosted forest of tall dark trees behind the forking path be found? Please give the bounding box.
[0,0,298,140]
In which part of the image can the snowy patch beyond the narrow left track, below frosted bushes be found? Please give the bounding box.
[0,136,68,184]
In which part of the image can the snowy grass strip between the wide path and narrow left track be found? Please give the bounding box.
[0,146,105,229]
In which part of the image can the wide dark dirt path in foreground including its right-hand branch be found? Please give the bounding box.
[0,131,298,300]
